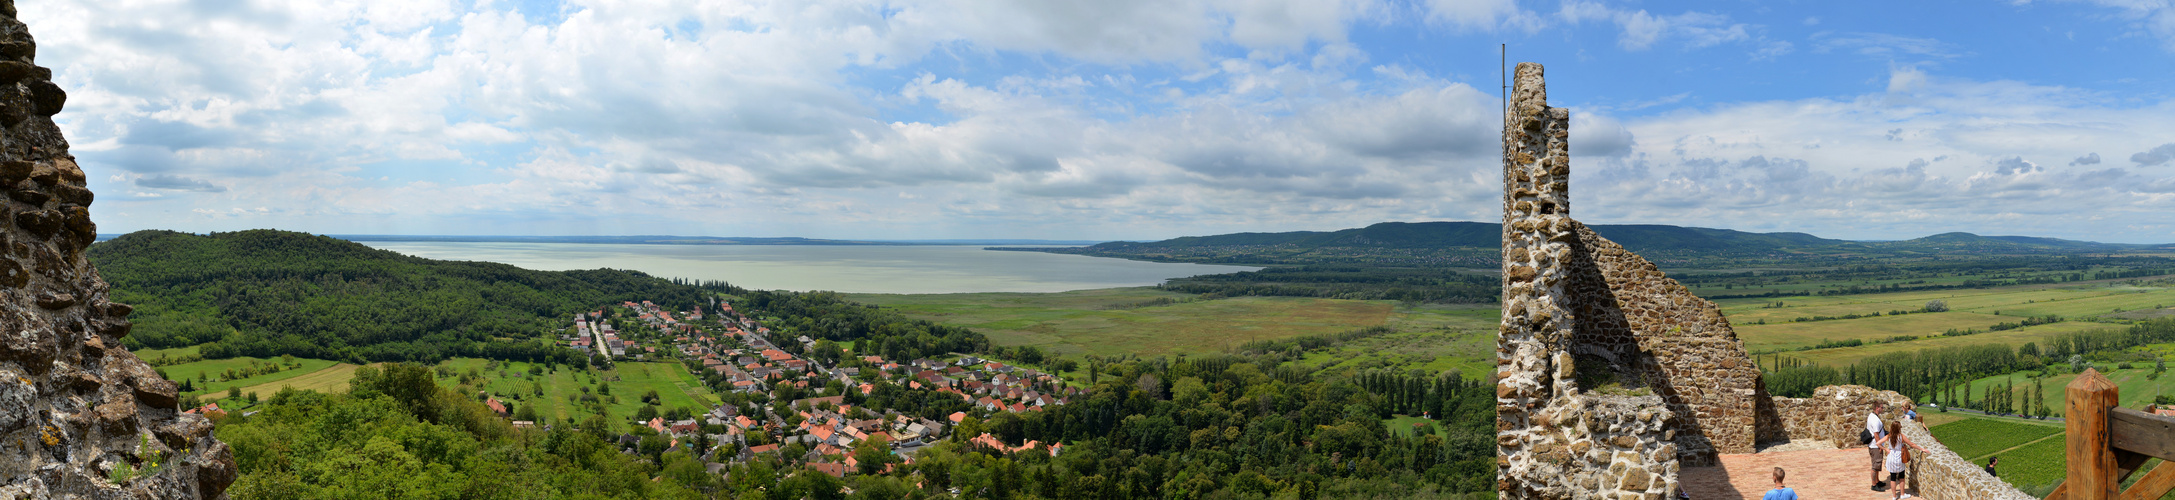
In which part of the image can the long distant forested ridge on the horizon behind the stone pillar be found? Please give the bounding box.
[1004,222,2149,267]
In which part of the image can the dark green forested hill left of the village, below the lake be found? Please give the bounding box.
[87,230,724,361]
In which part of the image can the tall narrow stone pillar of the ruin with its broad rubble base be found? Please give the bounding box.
[1496,63,1686,498]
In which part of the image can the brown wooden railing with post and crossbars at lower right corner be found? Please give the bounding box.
[2047,370,2175,500]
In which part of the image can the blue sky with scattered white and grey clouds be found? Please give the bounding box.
[17,0,2175,243]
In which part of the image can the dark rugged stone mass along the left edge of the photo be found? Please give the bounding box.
[0,0,235,498]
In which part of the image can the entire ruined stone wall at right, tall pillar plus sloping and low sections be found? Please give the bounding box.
[1496,63,2016,500]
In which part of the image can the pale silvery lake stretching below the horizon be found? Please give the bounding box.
[359,241,1259,293]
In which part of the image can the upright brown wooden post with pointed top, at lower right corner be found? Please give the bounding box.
[2062,370,2121,500]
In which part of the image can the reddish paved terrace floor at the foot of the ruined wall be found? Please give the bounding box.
[1677,448,1938,500]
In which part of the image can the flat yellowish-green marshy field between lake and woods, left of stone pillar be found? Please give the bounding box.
[846,287,1426,357]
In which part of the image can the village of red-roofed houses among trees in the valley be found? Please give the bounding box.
[543,300,1083,476]
